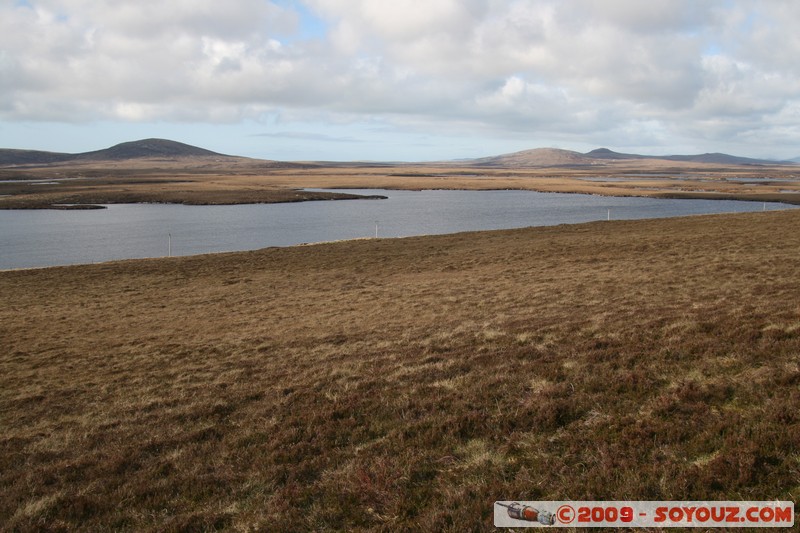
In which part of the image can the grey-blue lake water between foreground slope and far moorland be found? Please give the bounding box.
[0,189,790,269]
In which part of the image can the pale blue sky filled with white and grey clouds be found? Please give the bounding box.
[0,0,800,161]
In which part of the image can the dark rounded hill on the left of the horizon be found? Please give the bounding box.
[0,139,230,166]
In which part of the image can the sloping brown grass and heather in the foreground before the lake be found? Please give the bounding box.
[0,211,800,531]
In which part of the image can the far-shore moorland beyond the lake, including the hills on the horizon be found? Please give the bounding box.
[0,139,800,209]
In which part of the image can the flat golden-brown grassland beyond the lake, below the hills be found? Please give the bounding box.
[0,158,800,209]
